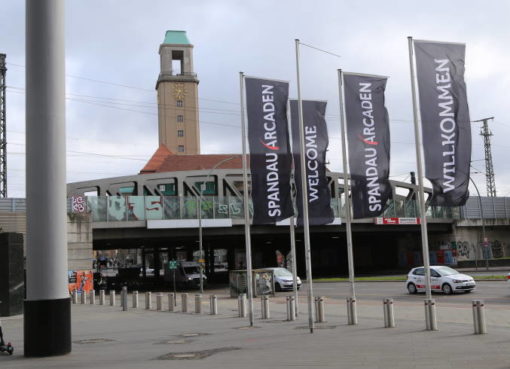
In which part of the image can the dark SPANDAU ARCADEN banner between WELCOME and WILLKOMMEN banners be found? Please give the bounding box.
[343,73,392,219]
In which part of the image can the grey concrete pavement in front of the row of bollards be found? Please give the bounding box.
[0,291,510,369]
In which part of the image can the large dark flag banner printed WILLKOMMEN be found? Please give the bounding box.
[414,41,471,206]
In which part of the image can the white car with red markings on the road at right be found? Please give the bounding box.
[406,265,476,295]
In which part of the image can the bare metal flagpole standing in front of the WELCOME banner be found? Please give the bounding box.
[295,39,314,333]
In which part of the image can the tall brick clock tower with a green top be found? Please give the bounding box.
[156,31,200,155]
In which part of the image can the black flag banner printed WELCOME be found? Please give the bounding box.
[290,100,334,225]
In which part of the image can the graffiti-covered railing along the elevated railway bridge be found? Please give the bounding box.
[69,196,458,222]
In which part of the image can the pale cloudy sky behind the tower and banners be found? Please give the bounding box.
[0,0,510,197]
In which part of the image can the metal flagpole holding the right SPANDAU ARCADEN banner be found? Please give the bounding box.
[338,69,358,325]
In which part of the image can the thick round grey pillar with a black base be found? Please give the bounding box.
[23,0,71,357]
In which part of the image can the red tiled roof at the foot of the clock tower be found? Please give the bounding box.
[140,145,243,174]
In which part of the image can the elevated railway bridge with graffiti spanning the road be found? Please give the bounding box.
[62,169,510,276]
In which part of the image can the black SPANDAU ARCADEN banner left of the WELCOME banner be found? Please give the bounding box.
[245,77,294,224]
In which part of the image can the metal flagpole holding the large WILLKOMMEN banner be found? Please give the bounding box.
[407,37,435,330]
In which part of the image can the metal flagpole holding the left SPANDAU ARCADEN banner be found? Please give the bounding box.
[239,72,253,327]
